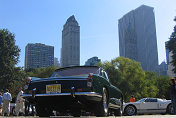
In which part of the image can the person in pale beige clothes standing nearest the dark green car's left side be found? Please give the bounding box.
[15,87,24,116]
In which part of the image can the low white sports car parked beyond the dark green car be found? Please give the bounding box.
[123,98,173,116]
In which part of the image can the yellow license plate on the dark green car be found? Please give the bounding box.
[46,84,61,93]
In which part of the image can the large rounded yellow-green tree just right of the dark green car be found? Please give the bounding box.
[101,57,145,101]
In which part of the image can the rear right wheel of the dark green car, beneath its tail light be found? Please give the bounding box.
[96,87,108,116]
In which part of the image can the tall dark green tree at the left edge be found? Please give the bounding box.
[0,29,20,89]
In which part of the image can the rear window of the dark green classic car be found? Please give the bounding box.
[51,67,99,77]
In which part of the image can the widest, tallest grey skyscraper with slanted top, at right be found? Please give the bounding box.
[118,5,158,72]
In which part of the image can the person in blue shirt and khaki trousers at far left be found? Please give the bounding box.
[2,89,12,116]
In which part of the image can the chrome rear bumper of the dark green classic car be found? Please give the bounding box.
[22,92,102,98]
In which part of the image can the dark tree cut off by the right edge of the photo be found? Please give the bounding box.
[166,17,176,73]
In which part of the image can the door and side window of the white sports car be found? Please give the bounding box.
[140,98,159,113]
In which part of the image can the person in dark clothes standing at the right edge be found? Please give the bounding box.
[170,78,176,114]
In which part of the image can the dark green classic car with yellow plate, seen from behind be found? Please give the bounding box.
[23,66,123,116]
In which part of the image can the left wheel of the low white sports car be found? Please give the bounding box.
[125,105,137,116]
